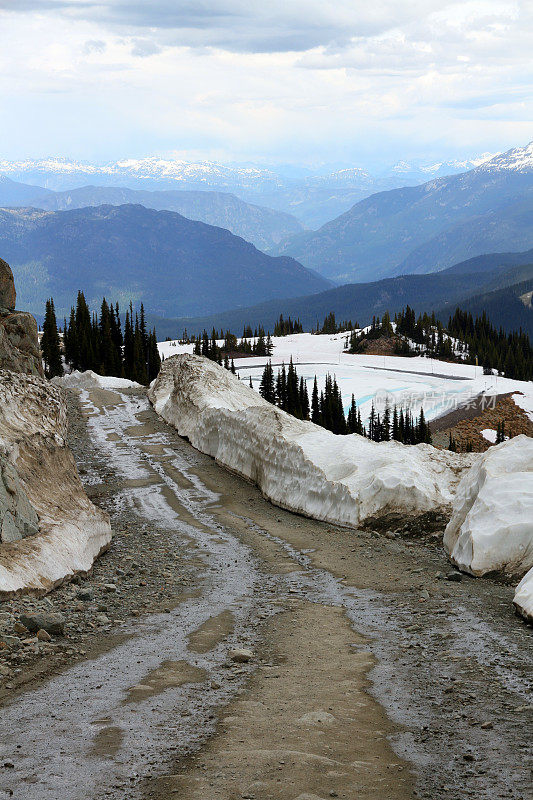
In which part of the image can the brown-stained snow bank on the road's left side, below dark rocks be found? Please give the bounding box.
[0,371,111,596]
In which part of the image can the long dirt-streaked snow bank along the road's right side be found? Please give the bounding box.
[148,355,472,526]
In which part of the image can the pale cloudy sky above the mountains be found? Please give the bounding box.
[0,0,533,168]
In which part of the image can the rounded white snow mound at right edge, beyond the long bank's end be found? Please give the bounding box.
[444,435,533,575]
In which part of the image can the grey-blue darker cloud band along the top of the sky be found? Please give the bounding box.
[0,0,442,52]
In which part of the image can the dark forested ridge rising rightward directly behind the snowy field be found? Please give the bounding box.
[148,250,533,338]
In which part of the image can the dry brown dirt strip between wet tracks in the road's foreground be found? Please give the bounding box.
[151,602,413,800]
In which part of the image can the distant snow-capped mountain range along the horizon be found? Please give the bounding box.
[0,154,496,228]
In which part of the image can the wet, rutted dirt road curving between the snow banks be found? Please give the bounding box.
[0,391,533,800]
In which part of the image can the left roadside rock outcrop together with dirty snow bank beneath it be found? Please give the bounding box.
[0,259,111,597]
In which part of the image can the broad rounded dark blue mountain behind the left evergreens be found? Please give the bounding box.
[0,205,331,317]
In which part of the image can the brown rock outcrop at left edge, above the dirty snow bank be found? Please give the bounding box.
[0,258,44,376]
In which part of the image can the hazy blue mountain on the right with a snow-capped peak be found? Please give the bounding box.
[278,142,533,283]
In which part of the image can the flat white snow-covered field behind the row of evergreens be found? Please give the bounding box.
[158,333,533,428]
